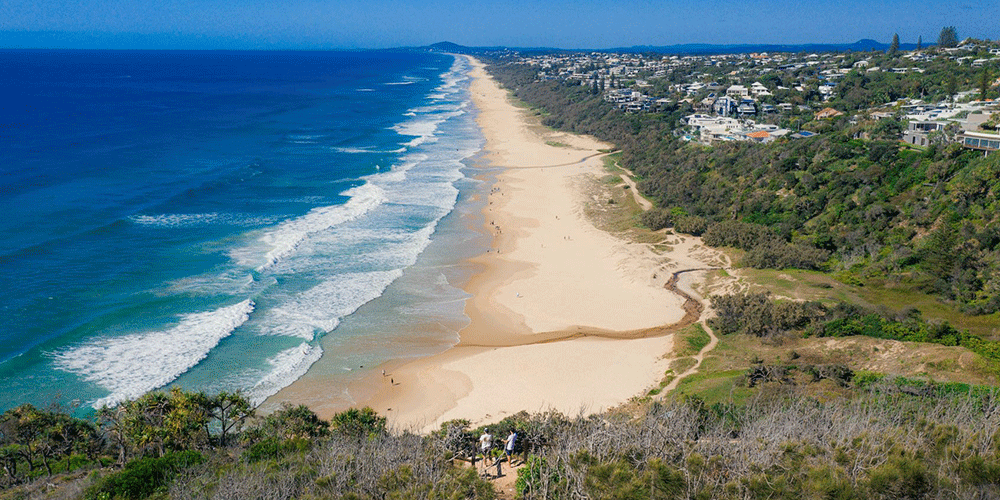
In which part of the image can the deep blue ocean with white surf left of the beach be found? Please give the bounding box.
[0,51,482,411]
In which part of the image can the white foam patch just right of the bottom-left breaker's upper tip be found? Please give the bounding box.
[261,269,403,340]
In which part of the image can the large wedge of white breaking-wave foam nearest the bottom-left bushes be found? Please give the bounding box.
[52,299,254,408]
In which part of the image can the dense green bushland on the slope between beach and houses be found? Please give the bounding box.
[490,47,1000,315]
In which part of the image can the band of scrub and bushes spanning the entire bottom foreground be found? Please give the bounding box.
[0,380,1000,499]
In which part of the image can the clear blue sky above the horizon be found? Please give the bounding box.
[0,0,1000,50]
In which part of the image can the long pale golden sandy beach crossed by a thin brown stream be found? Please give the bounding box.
[278,53,728,432]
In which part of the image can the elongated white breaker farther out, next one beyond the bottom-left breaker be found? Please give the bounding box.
[254,183,386,271]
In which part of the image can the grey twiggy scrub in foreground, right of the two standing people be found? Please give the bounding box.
[517,390,1000,500]
